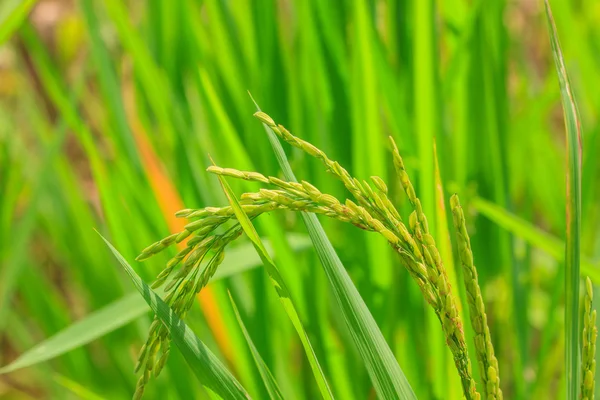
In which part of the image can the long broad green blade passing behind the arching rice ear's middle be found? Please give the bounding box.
[253,99,416,399]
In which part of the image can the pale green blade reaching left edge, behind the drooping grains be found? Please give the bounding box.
[0,235,310,375]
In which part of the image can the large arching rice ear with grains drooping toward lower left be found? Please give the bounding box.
[140,112,482,400]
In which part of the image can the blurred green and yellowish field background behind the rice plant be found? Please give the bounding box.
[0,0,600,399]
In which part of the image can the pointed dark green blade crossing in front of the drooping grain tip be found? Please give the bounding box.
[100,235,250,399]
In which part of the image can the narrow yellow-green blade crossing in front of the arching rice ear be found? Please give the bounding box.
[219,176,333,399]
